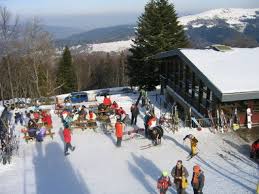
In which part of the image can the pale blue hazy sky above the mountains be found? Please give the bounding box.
[0,0,259,28]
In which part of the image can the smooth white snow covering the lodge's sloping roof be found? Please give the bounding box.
[181,47,259,93]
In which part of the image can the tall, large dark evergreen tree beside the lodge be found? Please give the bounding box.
[128,0,188,90]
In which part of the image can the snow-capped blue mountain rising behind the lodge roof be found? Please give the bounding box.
[179,8,259,47]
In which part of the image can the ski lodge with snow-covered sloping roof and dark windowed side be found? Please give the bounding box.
[152,46,259,125]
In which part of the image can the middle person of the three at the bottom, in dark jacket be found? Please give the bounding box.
[171,160,189,194]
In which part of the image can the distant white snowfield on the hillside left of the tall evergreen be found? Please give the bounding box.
[91,40,133,52]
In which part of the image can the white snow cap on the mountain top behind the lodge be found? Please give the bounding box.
[179,8,259,31]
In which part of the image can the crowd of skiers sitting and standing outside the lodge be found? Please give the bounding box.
[0,89,209,194]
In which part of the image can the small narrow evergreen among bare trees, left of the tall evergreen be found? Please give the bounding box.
[57,46,77,93]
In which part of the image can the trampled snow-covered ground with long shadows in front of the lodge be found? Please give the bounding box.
[0,94,259,194]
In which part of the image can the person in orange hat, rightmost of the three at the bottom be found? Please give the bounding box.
[191,165,205,194]
